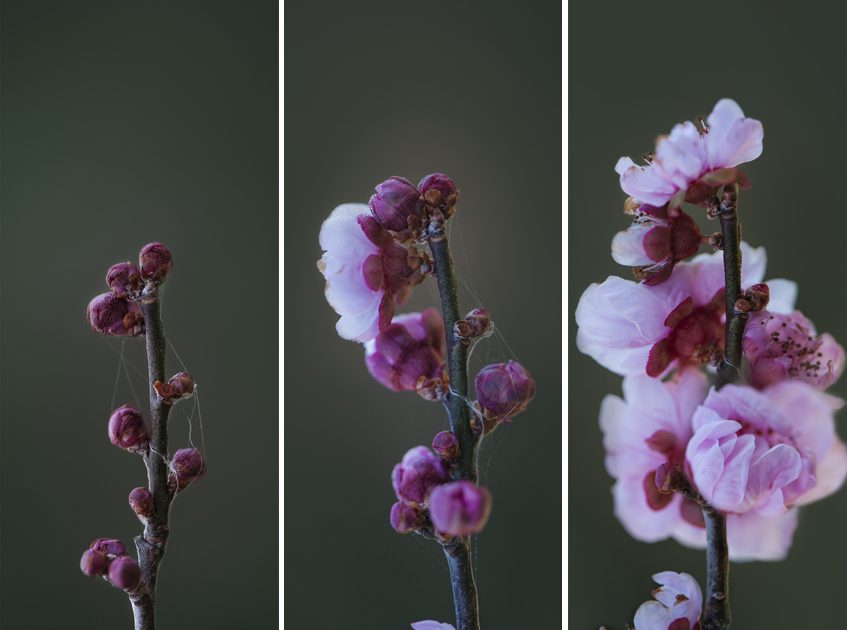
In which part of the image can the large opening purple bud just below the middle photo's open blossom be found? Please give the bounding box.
[365,308,446,391]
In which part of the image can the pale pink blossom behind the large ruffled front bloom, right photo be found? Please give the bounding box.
[600,368,797,562]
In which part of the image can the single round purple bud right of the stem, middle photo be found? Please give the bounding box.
[474,361,535,421]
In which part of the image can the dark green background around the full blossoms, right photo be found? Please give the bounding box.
[568,1,847,629]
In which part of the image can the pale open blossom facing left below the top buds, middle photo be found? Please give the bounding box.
[318,203,427,342]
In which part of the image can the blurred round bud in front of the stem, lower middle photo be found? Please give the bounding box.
[429,481,491,536]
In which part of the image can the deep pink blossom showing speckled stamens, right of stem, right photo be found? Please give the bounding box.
[744,310,844,389]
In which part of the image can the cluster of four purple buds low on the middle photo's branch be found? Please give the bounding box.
[389,442,491,539]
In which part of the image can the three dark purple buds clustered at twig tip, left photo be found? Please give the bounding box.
[85,243,173,337]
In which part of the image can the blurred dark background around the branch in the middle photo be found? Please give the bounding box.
[284,1,562,630]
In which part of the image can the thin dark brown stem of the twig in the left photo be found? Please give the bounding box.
[130,282,173,630]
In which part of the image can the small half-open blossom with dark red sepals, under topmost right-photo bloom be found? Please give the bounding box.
[612,205,701,285]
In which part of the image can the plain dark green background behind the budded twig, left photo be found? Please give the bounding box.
[0,0,279,630]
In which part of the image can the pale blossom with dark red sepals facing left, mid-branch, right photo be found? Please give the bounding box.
[576,243,772,376]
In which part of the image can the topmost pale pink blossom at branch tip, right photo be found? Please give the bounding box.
[615,98,764,207]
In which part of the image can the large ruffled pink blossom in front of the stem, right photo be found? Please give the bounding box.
[685,381,847,516]
